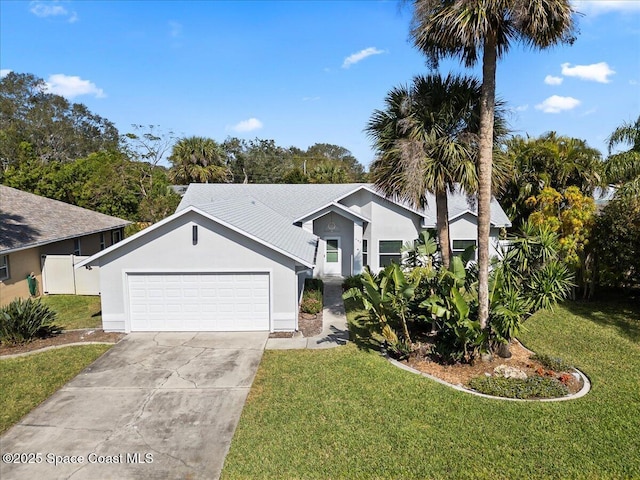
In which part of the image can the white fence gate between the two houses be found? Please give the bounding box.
[42,255,100,295]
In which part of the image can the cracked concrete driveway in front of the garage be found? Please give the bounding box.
[0,332,268,480]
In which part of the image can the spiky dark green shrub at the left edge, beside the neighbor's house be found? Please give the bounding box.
[0,298,61,343]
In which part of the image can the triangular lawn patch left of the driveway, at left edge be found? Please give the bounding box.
[0,345,111,433]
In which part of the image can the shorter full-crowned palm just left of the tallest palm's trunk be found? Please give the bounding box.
[366,75,503,268]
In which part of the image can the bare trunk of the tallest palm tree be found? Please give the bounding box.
[477,35,497,329]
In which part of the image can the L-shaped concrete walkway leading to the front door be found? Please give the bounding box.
[266,277,349,350]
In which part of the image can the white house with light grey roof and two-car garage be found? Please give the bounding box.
[78,184,510,332]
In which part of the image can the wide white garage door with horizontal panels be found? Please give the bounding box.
[128,273,269,332]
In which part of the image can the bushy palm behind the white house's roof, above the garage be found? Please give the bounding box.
[169,137,231,184]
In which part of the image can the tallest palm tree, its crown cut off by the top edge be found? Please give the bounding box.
[411,0,574,328]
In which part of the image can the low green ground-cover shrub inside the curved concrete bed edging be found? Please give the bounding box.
[469,376,569,398]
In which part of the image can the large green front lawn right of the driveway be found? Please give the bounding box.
[223,303,640,479]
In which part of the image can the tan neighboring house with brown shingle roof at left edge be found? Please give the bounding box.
[0,185,130,305]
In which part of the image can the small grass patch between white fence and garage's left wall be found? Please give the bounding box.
[42,295,102,330]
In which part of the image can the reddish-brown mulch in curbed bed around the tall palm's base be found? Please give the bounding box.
[404,342,582,394]
